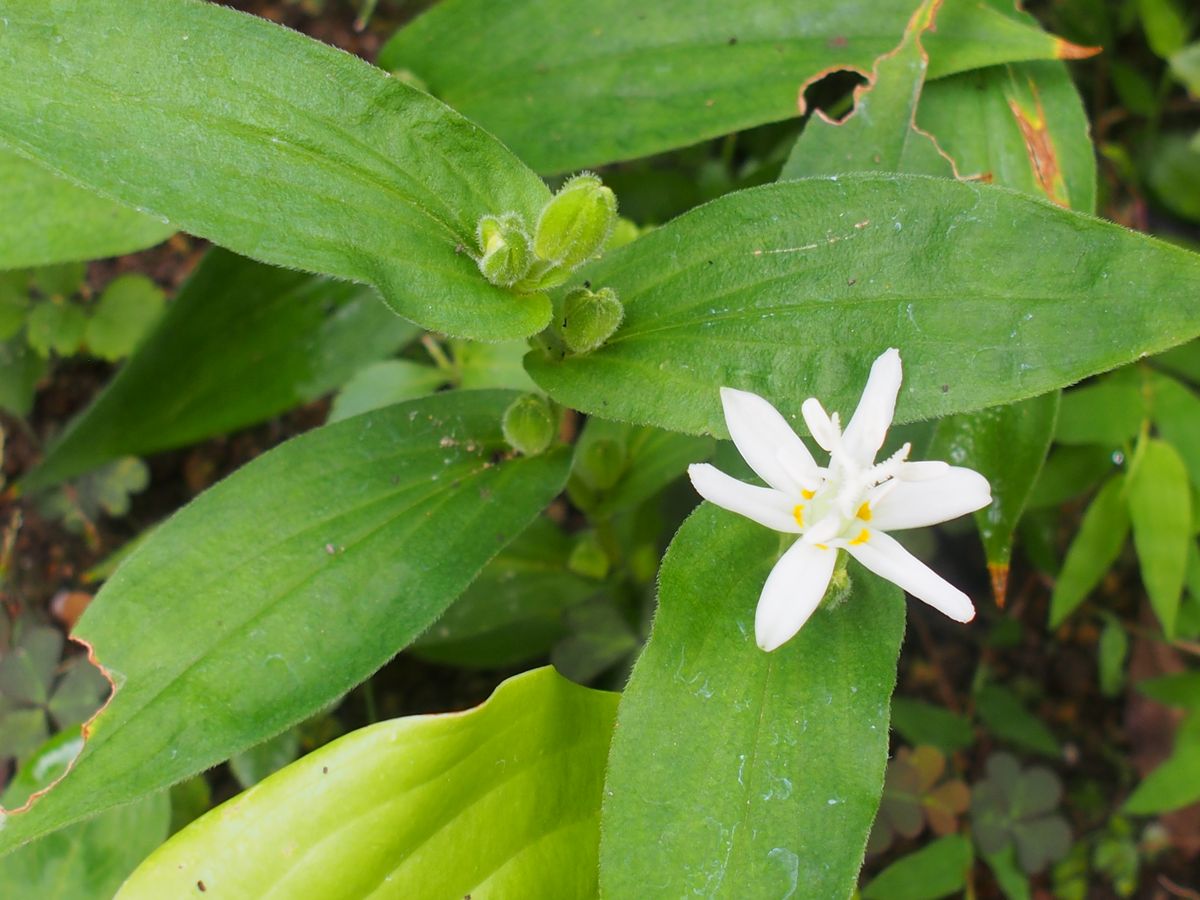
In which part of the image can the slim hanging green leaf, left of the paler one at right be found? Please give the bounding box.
[1050,475,1129,628]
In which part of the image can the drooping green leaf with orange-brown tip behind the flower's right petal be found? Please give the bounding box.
[929,391,1058,592]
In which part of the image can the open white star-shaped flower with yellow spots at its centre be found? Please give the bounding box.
[688,349,991,650]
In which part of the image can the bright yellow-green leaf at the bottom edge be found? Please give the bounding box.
[118,668,617,900]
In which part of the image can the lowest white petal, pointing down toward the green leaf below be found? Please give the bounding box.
[754,541,838,652]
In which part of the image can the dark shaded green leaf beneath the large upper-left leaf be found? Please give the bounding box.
[24,250,416,490]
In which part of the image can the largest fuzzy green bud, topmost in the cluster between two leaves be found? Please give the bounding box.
[533,173,617,270]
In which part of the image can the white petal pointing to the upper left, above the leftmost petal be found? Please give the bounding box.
[721,388,817,496]
